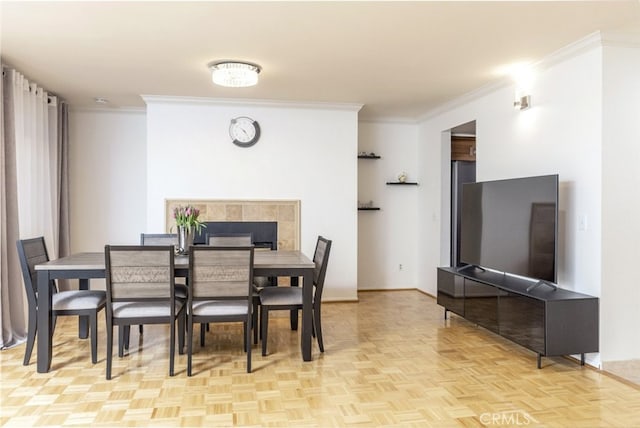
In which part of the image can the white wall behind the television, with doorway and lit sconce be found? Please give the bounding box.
[418,39,606,365]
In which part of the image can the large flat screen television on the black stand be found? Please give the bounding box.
[460,175,558,283]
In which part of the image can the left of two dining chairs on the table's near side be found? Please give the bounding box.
[104,245,186,380]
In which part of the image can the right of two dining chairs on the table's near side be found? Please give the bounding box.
[187,246,254,376]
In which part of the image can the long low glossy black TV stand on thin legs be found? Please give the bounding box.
[438,267,599,368]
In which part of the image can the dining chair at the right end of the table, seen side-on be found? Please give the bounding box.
[260,236,331,356]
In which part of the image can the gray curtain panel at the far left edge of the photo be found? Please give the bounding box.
[0,67,27,348]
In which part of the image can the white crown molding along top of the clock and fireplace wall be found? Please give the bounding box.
[140,95,363,112]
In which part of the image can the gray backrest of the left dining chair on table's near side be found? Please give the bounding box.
[104,245,175,307]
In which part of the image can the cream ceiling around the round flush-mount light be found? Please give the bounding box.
[0,0,640,120]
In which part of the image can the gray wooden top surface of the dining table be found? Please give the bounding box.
[35,250,315,270]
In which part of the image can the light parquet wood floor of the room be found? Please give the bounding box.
[0,290,640,427]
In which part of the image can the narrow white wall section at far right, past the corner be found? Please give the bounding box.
[600,43,640,362]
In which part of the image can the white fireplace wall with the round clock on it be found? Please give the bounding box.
[145,97,359,300]
